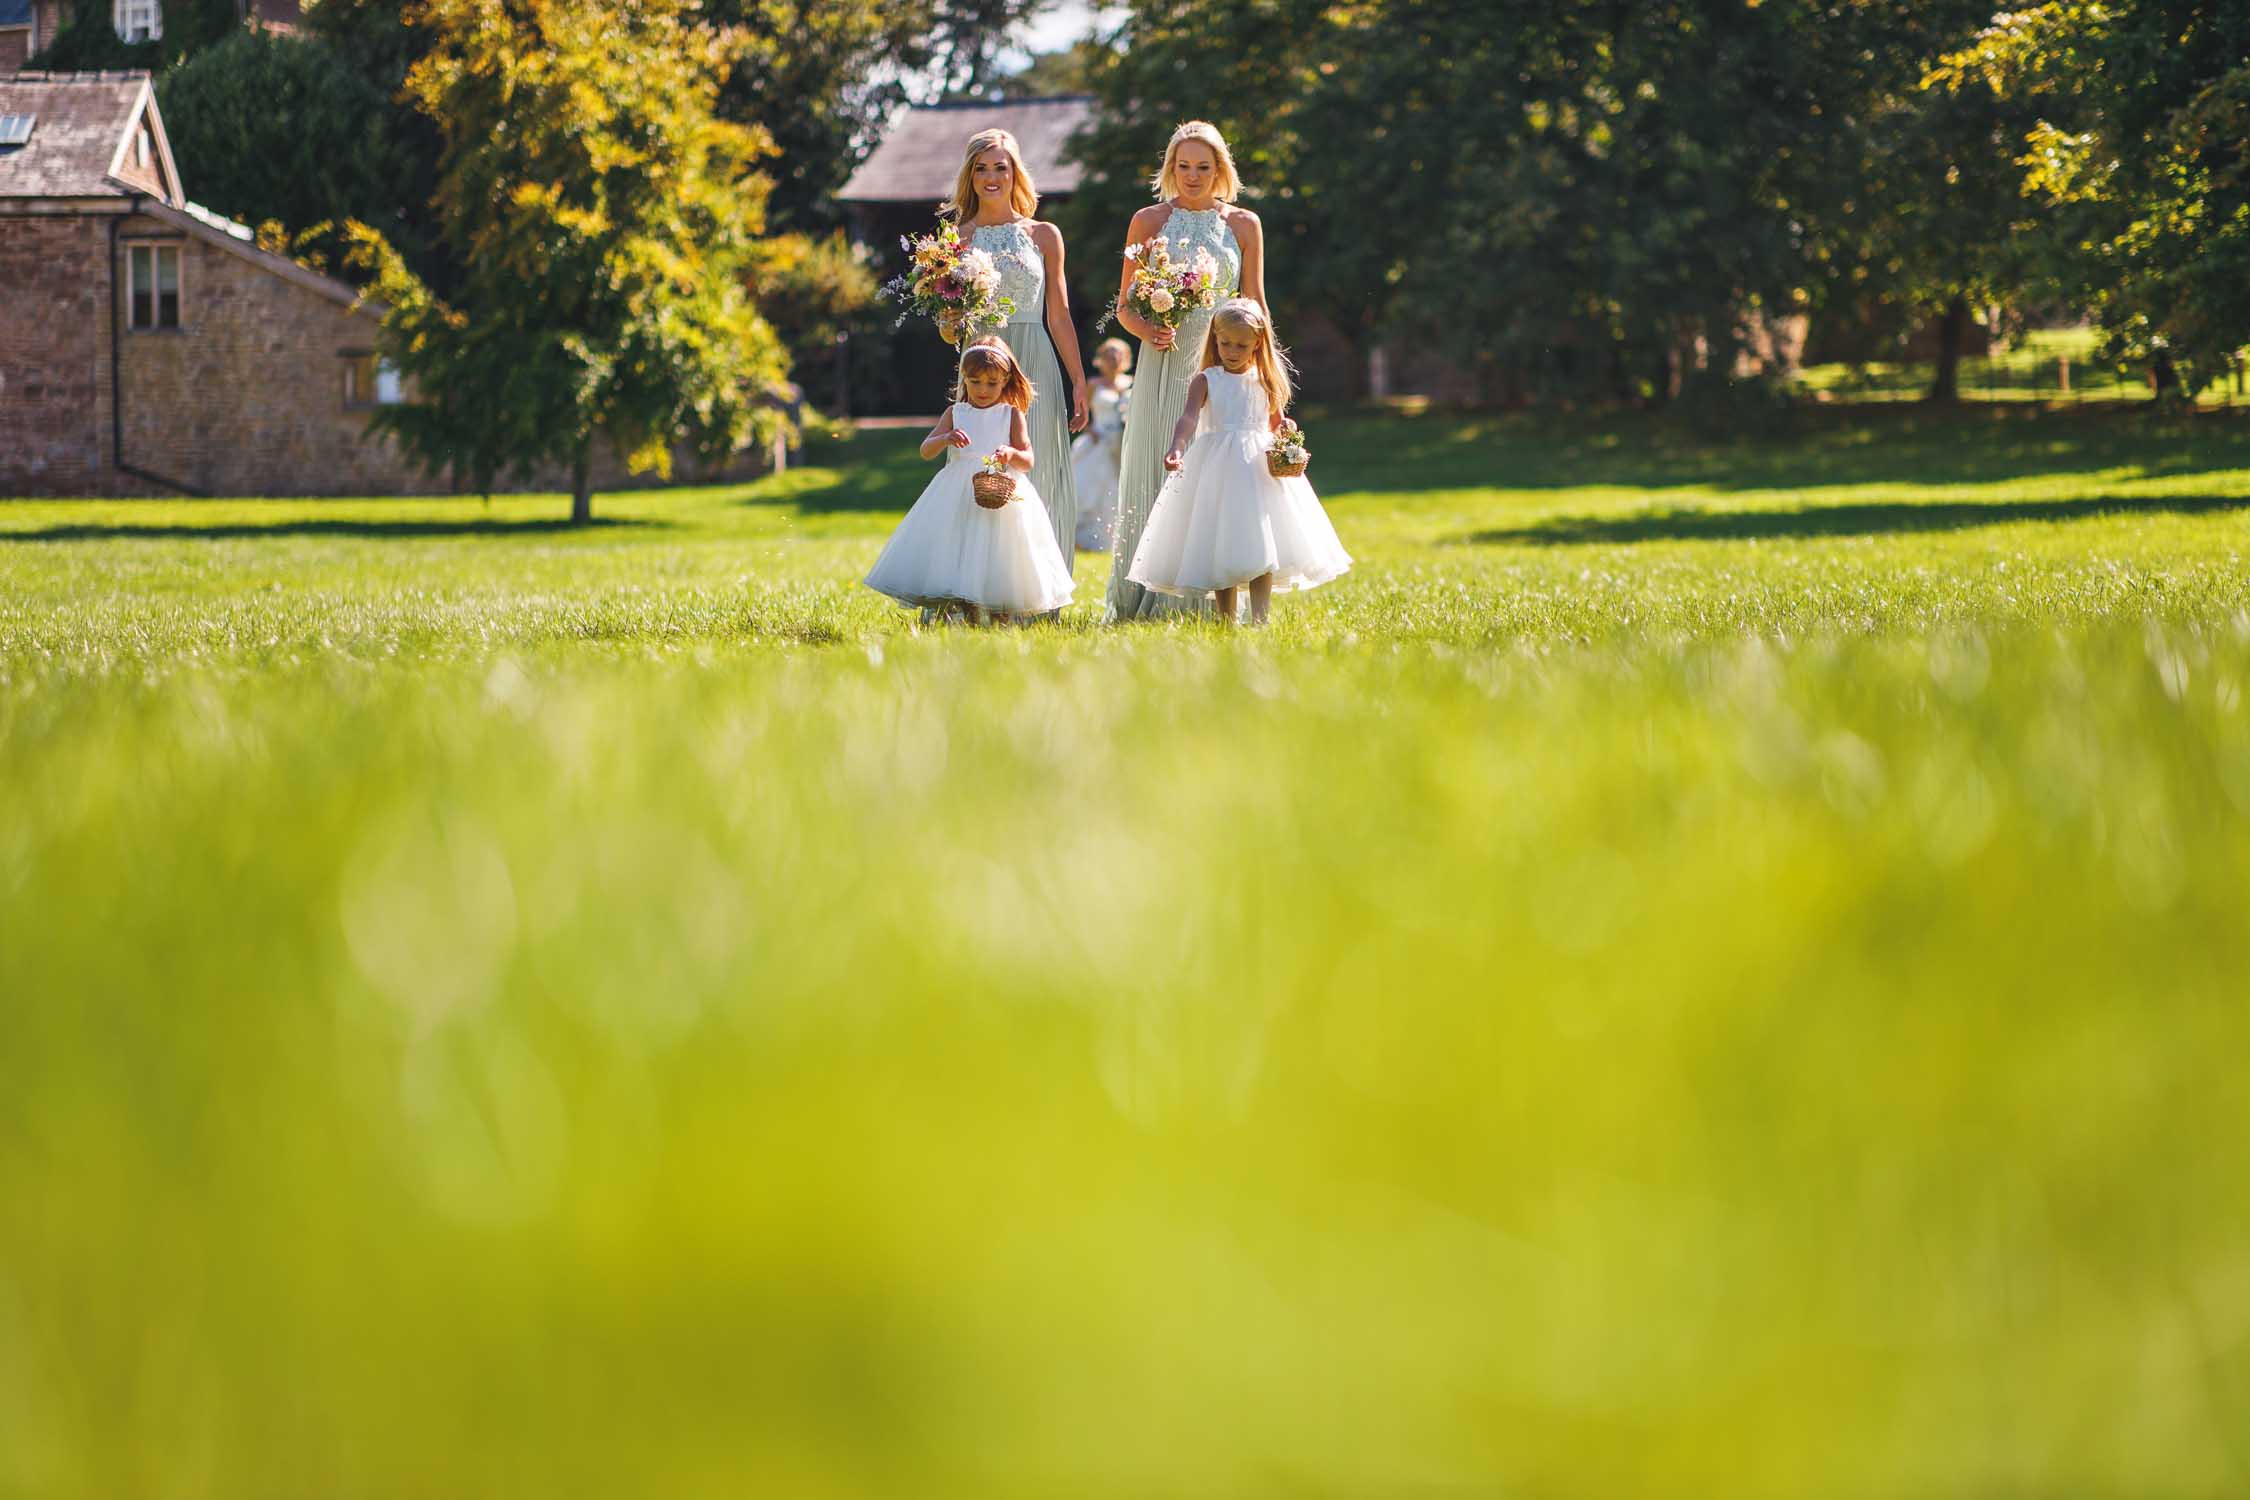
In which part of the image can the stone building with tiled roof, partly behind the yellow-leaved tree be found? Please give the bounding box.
[0,72,765,495]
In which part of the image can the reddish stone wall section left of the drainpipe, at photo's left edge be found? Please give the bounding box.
[0,216,110,495]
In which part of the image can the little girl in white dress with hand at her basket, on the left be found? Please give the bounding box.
[866,340,1073,625]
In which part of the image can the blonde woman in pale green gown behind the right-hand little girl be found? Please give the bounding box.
[1105,119,1265,621]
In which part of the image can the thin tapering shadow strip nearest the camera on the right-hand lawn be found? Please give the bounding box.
[1454,495,2250,546]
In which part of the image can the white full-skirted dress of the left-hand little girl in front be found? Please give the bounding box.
[866,400,1076,614]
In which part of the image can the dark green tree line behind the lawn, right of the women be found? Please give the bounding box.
[1071,0,2250,398]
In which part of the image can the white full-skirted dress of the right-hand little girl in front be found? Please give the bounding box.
[1127,364,1352,594]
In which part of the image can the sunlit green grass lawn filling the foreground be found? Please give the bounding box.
[0,405,2250,1498]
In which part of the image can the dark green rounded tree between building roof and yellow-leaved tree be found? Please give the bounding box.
[155,27,434,274]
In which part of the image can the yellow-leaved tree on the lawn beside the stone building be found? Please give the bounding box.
[337,0,785,522]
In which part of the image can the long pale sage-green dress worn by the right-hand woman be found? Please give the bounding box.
[1103,209,1242,623]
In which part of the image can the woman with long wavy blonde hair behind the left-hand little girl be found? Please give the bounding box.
[941,130,1087,571]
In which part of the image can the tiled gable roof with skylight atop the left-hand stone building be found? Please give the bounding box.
[0,72,185,205]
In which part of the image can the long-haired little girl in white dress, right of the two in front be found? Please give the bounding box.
[1127,297,1352,623]
